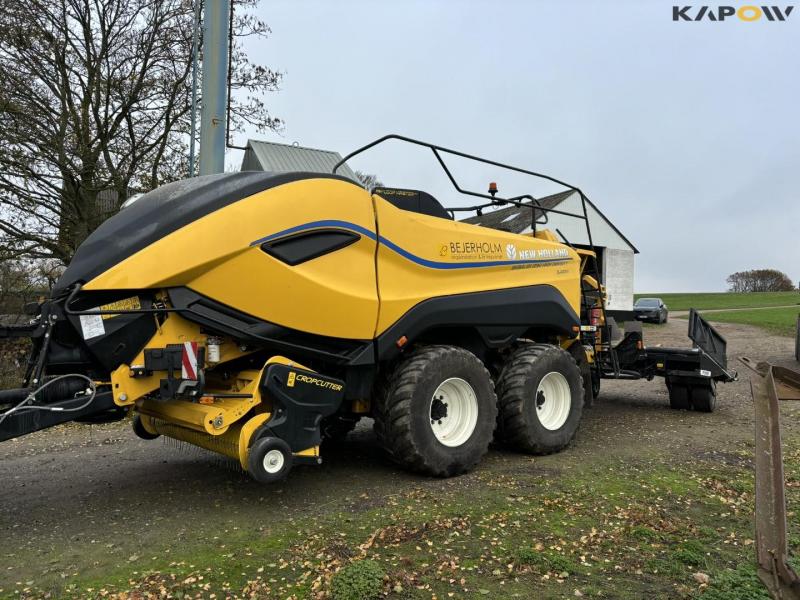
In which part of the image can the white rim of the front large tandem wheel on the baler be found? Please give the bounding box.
[428,377,478,448]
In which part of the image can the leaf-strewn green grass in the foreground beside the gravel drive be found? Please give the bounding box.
[9,452,798,600]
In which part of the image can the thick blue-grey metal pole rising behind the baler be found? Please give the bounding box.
[200,0,230,175]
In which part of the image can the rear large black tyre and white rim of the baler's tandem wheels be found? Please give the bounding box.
[497,344,584,454]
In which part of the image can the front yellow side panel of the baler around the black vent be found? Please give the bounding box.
[84,179,378,339]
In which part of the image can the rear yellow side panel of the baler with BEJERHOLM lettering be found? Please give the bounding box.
[373,195,580,334]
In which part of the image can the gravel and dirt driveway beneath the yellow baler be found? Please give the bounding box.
[0,321,797,591]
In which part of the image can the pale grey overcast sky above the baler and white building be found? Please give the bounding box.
[228,0,800,292]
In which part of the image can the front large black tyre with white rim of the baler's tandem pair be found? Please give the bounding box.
[374,346,497,477]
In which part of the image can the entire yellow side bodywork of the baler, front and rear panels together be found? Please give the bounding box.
[84,179,580,346]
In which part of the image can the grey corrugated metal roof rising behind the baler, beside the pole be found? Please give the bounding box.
[241,140,358,183]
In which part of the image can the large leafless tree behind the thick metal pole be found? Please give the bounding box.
[0,0,282,262]
